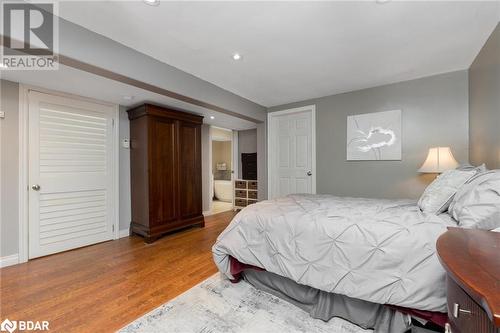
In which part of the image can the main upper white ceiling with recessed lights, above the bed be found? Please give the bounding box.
[59,1,500,106]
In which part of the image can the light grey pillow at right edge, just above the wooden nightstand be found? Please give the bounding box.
[449,170,500,230]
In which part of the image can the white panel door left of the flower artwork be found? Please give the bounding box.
[269,106,316,199]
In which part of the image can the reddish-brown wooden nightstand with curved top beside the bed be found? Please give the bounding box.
[437,228,500,333]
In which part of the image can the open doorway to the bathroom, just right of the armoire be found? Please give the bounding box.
[211,126,234,214]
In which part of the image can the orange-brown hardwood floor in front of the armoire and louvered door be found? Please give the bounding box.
[0,211,235,332]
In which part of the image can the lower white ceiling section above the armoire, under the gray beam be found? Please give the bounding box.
[0,65,256,130]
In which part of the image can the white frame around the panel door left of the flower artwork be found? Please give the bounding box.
[267,104,316,199]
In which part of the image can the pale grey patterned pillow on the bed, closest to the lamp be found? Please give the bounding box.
[418,170,477,214]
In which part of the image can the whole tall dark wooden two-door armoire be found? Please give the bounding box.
[128,104,205,243]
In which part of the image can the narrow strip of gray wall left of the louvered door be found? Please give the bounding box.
[0,80,19,257]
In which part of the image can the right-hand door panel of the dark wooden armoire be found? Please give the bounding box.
[178,121,202,219]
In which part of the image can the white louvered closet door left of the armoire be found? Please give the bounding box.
[29,91,116,258]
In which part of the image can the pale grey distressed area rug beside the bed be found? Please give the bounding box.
[120,273,372,333]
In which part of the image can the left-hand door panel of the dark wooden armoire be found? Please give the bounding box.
[149,117,178,227]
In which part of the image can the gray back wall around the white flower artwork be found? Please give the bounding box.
[269,71,469,198]
